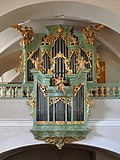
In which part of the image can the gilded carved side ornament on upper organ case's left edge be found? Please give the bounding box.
[14,54,24,79]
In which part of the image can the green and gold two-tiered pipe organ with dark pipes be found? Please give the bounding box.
[16,25,103,148]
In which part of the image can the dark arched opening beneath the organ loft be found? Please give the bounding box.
[0,144,120,160]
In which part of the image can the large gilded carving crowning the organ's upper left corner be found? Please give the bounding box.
[11,24,34,46]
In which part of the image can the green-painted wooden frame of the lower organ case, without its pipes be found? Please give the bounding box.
[31,69,89,148]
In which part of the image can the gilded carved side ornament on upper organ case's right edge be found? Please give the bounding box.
[96,53,105,79]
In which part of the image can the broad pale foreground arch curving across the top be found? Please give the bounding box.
[0,0,120,32]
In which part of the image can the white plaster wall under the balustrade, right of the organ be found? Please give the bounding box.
[89,99,120,121]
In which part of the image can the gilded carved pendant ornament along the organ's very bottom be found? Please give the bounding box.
[36,136,82,149]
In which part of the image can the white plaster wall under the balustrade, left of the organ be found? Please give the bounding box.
[0,99,32,120]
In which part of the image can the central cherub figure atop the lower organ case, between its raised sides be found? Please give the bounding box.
[55,76,65,94]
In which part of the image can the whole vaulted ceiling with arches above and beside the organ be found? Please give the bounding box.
[0,0,120,75]
